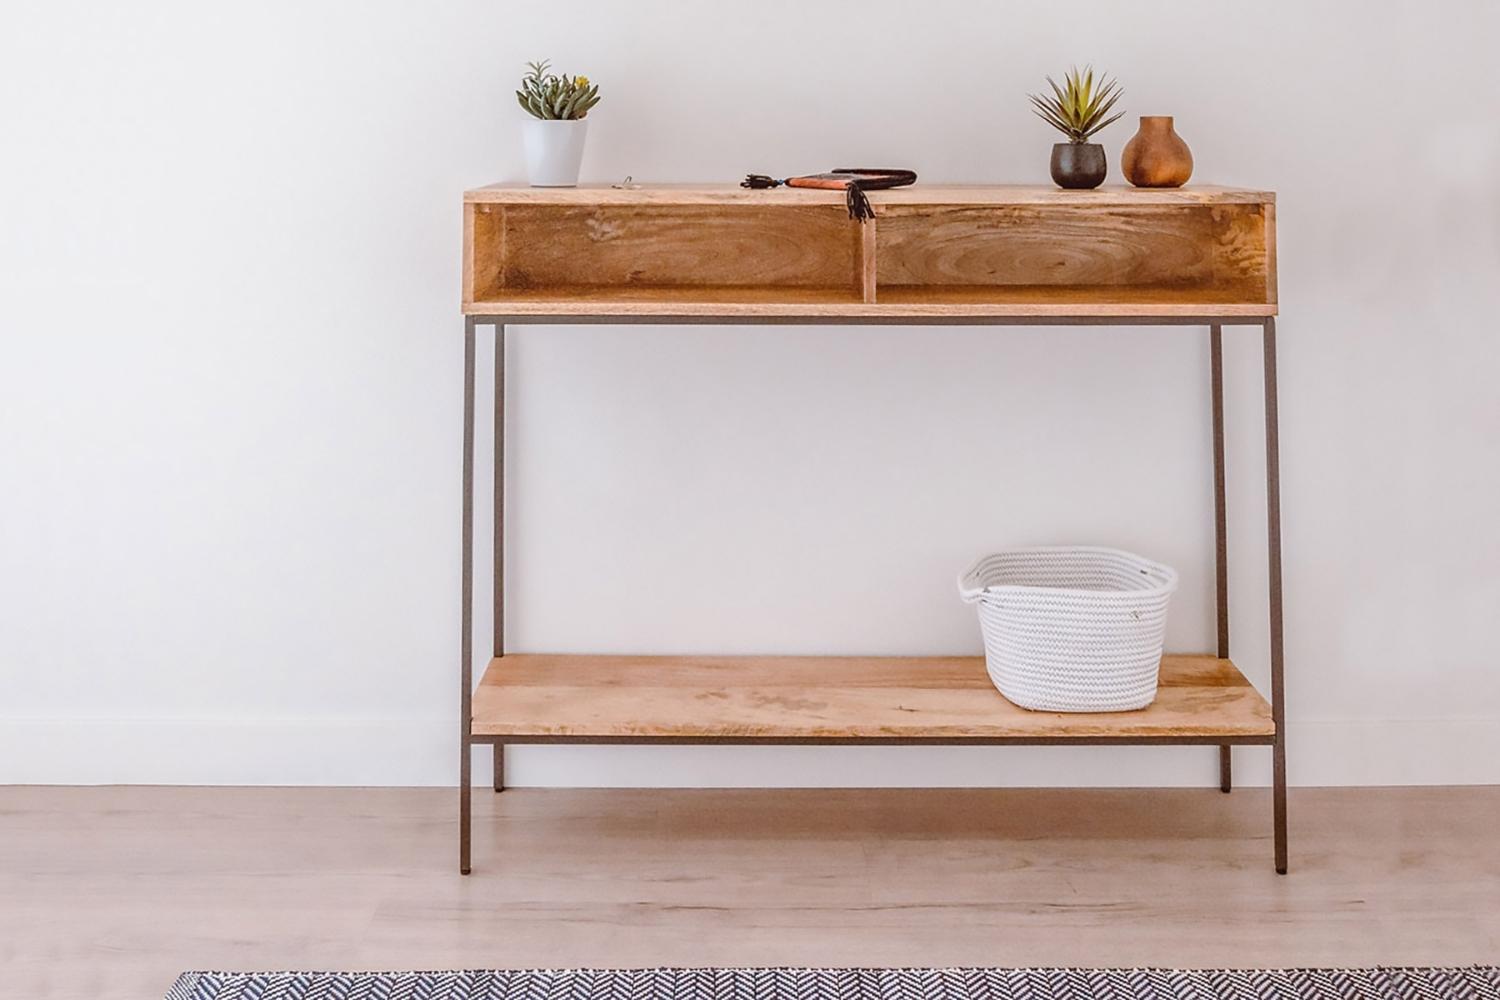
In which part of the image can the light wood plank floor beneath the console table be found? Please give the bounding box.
[0,787,1500,1000]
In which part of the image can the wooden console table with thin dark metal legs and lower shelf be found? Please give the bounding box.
[459,184,1287,874]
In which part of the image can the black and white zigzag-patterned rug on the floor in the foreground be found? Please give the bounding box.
[167,966,1500,1000]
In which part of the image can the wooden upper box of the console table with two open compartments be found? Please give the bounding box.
[464,186,1277,321]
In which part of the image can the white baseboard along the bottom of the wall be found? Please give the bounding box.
[0,718,1500,787]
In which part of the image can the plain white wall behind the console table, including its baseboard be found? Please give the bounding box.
[0,0,1500,784]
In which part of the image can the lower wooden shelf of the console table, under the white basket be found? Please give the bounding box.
[473,654,1275,744]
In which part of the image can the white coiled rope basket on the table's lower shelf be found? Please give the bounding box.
[959,546,1178,712]
